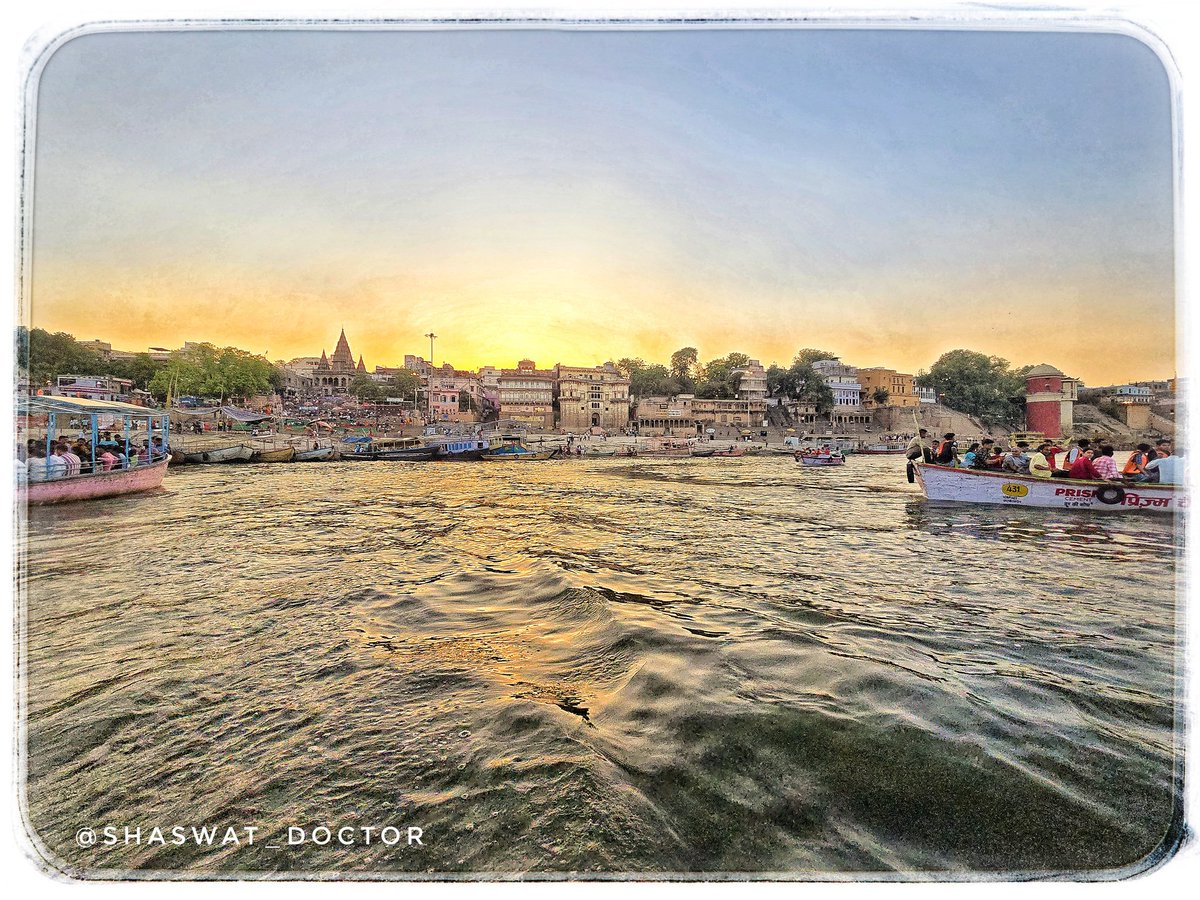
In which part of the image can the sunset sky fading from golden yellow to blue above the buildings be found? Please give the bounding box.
[29,29,1175,385]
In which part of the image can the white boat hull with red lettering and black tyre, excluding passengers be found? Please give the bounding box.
[913,462,1188,512]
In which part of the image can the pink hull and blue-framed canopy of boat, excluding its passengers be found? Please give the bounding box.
[17,396,170,505]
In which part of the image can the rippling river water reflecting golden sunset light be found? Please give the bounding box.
[24,456,1182,876]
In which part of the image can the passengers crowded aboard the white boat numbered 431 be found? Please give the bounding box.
[906,428,1184,485]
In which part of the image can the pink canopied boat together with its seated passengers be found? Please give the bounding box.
[16,396,170,505]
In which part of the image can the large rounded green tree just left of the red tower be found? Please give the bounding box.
[916,350,1025,425]
